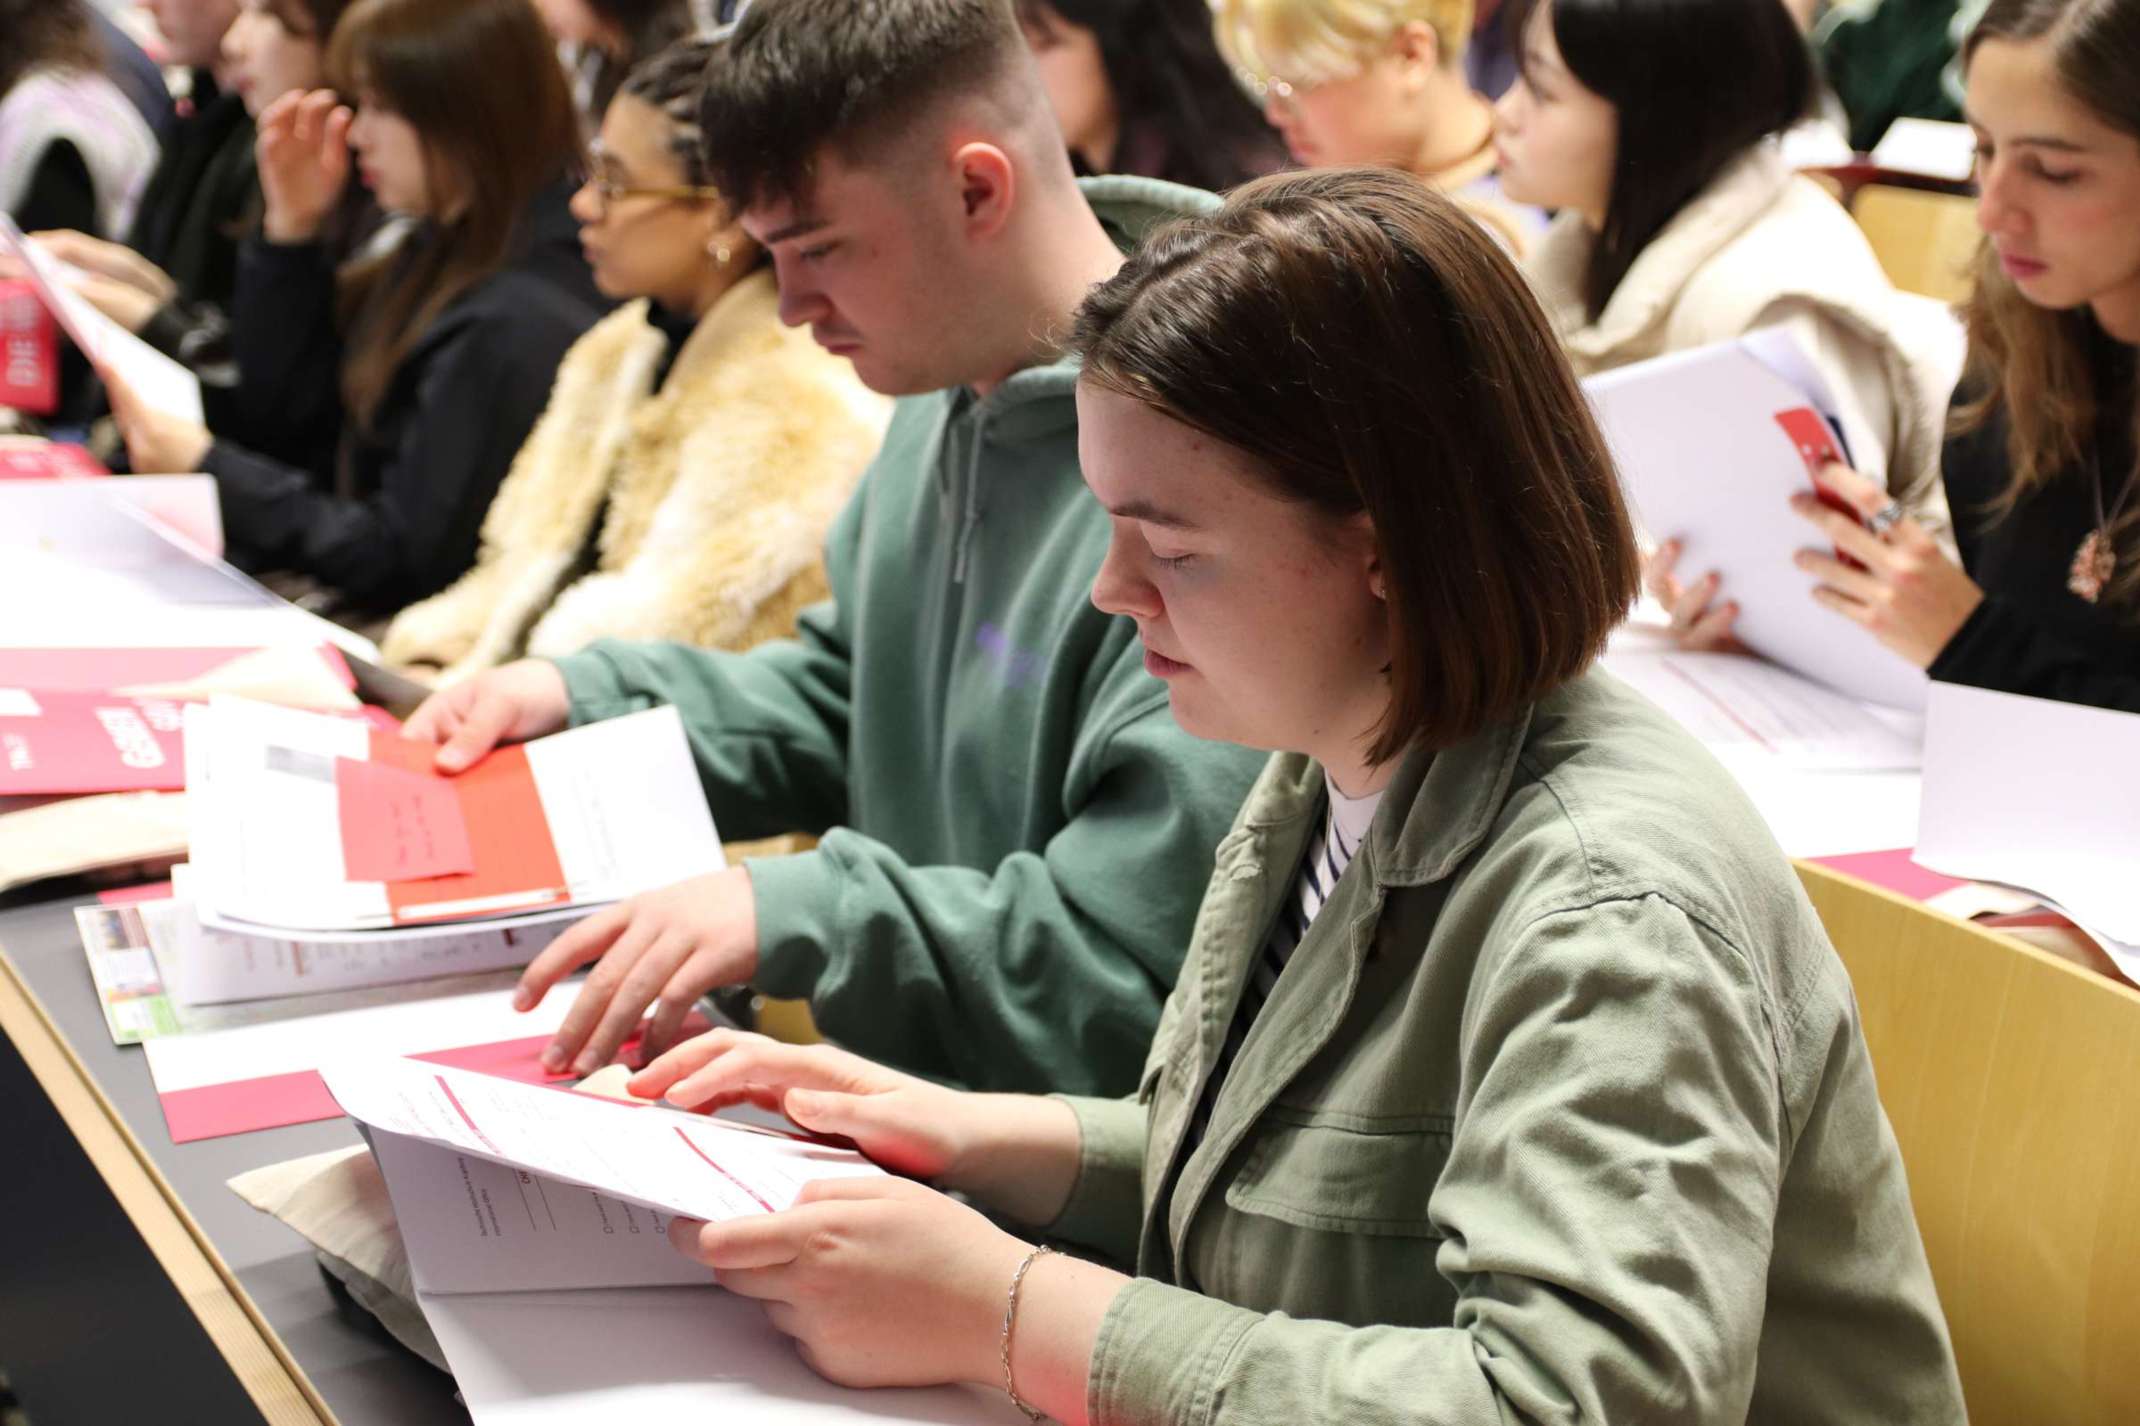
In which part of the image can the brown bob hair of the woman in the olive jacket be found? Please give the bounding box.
[1072,169,1639,762]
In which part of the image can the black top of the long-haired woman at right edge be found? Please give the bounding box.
[1930,343,2140,713]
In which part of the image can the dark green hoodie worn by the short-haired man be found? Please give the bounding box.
[559,180,1260,1094]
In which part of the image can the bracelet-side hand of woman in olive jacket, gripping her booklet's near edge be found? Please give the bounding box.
[670,1178,1031,1387]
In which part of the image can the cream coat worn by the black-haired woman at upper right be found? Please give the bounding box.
[1524,143,1958,533]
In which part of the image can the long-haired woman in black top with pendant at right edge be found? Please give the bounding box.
[1771,0,2140,713]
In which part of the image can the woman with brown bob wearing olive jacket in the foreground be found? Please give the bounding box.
[616,169,1962,1426]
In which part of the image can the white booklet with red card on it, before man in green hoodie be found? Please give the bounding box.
[186,698,723,940]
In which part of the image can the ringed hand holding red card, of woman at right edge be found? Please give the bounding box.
[1791,465,1984,668]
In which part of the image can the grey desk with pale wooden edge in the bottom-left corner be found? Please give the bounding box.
[0,901,467,1426]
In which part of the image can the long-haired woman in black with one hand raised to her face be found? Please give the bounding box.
[111,0,608,615]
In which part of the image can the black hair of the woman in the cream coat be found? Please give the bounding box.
[1509,0,1817,319]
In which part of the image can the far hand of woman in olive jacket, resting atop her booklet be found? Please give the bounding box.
[629,1030,976,1180]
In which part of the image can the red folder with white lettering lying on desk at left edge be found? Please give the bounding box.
[0,687,186,797]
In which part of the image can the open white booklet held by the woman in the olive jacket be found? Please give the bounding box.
[323,1058,1023,1426]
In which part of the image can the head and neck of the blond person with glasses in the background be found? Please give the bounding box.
[1218,0,1545,253]
